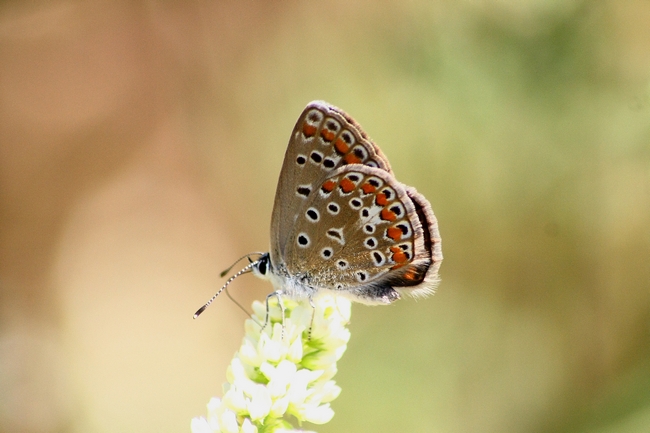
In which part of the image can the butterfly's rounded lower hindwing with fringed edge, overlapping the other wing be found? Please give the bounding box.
[285,164,442,304]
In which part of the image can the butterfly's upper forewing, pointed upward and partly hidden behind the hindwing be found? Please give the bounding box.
[270,101,391,268]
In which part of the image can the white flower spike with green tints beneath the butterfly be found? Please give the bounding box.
[191,294,351,433]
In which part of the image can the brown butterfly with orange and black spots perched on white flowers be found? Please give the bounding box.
[194,101,442,318]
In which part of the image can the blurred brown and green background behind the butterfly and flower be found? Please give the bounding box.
[0,0,650,433]
